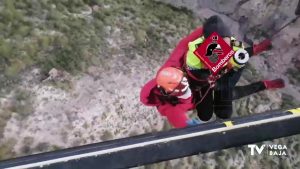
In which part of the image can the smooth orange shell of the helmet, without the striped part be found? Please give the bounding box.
[156,67,184,93]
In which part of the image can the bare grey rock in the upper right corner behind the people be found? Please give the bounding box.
[162,0,300,103]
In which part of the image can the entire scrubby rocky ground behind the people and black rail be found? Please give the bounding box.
[0,0,300,168]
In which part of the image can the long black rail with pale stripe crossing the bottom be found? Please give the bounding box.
[0,108,300,169]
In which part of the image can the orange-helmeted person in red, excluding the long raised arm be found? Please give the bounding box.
[140,67,200,128]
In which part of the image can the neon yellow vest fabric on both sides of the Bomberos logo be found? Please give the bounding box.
[186,36,244,69]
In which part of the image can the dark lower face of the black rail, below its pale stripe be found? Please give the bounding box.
[34,117,300,169]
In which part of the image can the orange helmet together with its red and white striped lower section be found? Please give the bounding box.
[156,67,189,96]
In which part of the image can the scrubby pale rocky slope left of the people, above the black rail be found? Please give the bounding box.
[0,1,200,159]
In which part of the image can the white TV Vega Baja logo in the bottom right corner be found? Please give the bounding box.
[248,144,287,156]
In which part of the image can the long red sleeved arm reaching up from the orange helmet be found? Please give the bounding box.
[161,27,203,69]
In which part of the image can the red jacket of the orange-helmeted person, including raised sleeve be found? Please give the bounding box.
[140,27,203,128]
